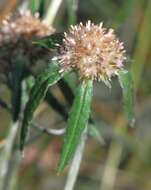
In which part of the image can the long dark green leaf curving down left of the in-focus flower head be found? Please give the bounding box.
[20,65,62,150]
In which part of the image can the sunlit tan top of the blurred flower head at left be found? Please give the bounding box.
[0,11,54,43]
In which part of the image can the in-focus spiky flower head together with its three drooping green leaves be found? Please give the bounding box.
[21,21,133,172]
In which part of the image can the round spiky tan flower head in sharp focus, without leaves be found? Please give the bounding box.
[58,21,126,84]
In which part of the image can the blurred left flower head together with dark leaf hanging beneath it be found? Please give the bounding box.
[0,11,54,122]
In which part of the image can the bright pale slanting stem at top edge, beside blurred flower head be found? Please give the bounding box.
[44,0,62,26]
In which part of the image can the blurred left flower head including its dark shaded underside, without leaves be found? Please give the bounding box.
[0,11,54,73]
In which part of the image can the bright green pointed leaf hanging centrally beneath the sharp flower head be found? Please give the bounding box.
[58,81,93,173]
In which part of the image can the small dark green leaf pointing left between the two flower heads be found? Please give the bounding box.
[33,33,63,49]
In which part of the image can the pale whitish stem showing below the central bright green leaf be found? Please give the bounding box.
[64,127,87,190]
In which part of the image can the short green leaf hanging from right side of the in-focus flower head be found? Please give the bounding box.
[118,70,134,126]
